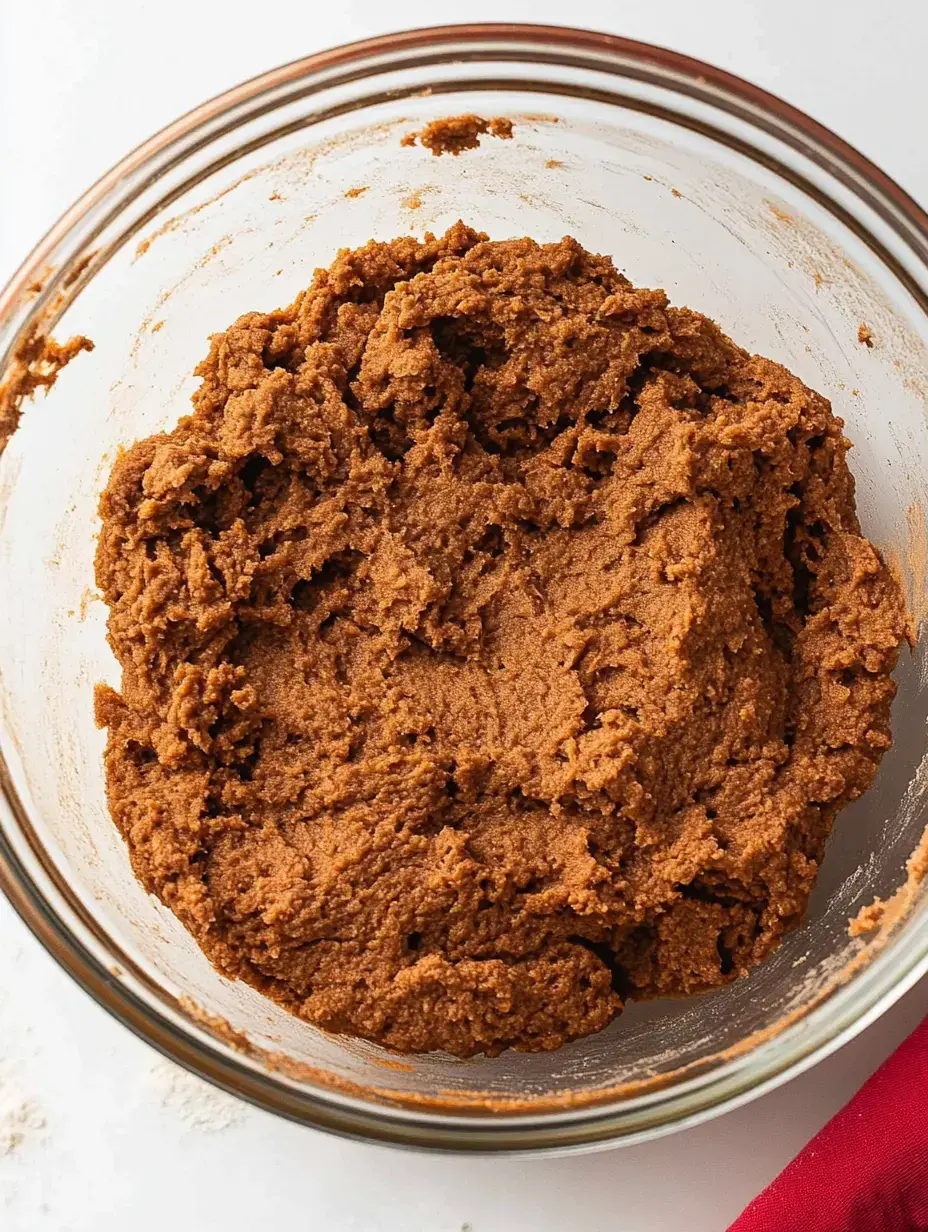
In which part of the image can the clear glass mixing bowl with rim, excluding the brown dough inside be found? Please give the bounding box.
[0,26,928,1152]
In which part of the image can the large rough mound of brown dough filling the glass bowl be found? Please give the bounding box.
[97,223,905,1055]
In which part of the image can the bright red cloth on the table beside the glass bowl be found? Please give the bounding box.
[728,1019,928,1232]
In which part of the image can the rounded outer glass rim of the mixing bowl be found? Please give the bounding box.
[0,22,928,1154]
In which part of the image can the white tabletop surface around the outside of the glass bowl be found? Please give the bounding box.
[0,0,928,1232]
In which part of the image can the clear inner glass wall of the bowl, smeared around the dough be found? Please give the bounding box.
[0,40,928,1143]
